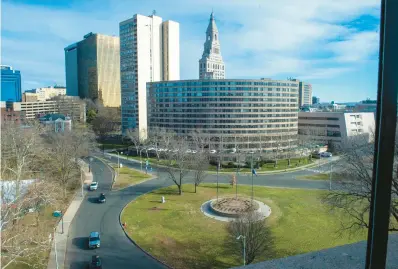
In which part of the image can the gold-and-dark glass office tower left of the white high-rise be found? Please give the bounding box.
[65,33,121,107]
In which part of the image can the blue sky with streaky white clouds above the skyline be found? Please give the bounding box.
[1,0,380,102]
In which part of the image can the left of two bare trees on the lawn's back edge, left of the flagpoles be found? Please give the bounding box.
[162,137,193,195]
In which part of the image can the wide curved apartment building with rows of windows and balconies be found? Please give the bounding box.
[147,79,299,152]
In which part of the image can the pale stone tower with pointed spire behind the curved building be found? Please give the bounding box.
[199,12,225,79]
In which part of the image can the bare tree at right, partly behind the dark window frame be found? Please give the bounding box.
[323,133,398,231]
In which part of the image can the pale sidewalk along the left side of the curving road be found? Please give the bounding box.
[47,161,93,269]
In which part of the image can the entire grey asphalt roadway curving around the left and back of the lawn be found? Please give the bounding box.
[65,155,338,269]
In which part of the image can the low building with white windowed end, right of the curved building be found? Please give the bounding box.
[298,112,375,145]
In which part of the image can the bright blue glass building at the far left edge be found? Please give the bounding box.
[0,65,22,102]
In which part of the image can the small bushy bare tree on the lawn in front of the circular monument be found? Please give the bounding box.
[227,211,273,264]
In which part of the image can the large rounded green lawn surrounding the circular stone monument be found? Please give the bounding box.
[122,184,367,268]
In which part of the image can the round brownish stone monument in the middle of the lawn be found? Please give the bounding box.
[210,197,259,218]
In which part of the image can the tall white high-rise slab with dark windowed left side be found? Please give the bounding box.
[119,14,180,138]
